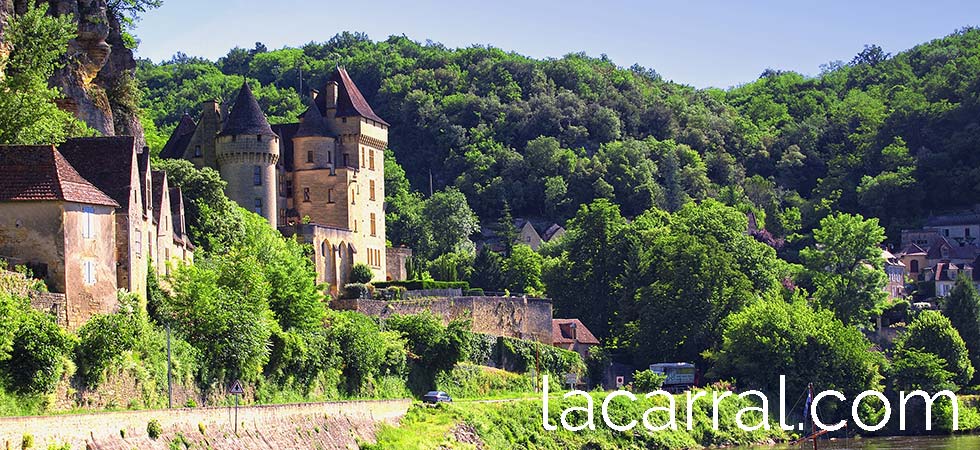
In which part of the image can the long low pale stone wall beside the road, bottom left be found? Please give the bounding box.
[0,400,411,450]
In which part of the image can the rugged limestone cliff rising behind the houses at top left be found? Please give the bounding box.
[0,0,144,145]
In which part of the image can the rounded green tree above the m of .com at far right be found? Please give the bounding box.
[895,311,974,386]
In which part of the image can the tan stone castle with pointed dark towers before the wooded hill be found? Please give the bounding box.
[160,67,394,292]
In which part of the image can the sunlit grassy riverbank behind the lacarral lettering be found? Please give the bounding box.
[362,386,786,450]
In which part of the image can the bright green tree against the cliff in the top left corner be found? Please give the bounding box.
[0,1,89,145]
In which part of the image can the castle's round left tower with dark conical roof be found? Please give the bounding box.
[215,82,279,227]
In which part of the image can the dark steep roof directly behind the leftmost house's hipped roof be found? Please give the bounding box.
[58,136,139,210]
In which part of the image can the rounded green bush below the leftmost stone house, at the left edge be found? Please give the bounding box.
[0,310,75,394]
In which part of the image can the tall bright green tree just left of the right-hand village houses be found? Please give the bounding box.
[800,213,887,325]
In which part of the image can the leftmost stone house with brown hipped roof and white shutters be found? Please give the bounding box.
[0,145,120,329]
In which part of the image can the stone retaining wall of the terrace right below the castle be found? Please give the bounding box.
[330,297,552,345]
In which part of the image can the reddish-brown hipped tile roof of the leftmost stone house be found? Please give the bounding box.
[0,145,119,207]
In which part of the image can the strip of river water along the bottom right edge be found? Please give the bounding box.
[735,436,980,450]
